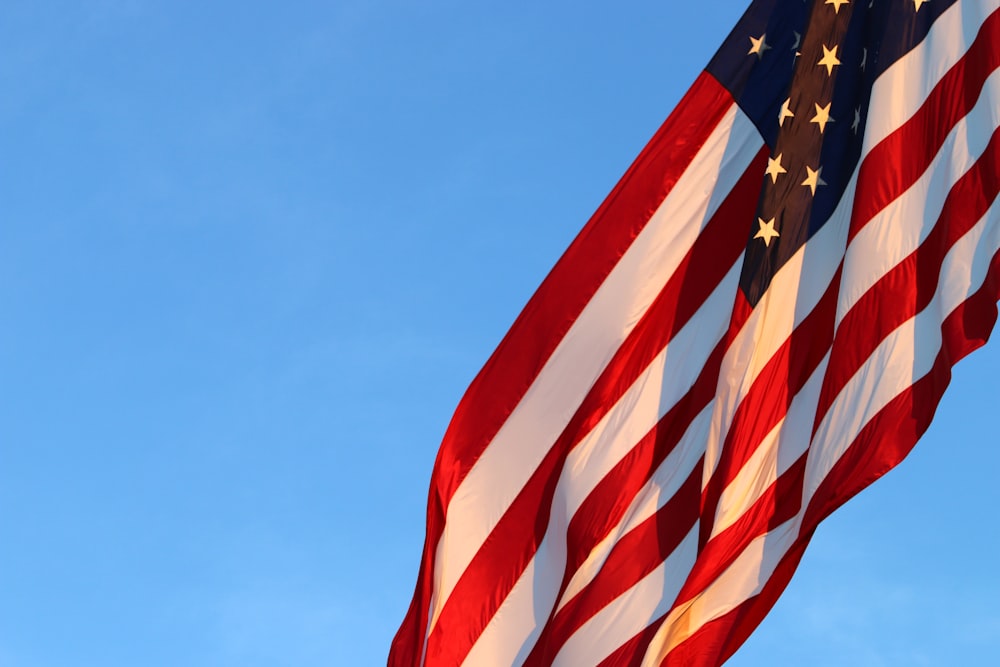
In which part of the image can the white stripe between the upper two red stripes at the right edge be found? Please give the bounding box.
[837,70,1000,324]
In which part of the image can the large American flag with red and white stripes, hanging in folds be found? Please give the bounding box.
[389,0,1000,667]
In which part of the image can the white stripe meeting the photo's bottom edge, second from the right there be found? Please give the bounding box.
[552,526,698,667]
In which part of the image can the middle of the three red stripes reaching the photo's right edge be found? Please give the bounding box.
[813,131,1000,435]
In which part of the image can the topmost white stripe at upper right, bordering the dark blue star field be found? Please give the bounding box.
[863,0,1000,153]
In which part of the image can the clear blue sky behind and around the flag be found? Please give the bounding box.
[0,0,1000,667]
